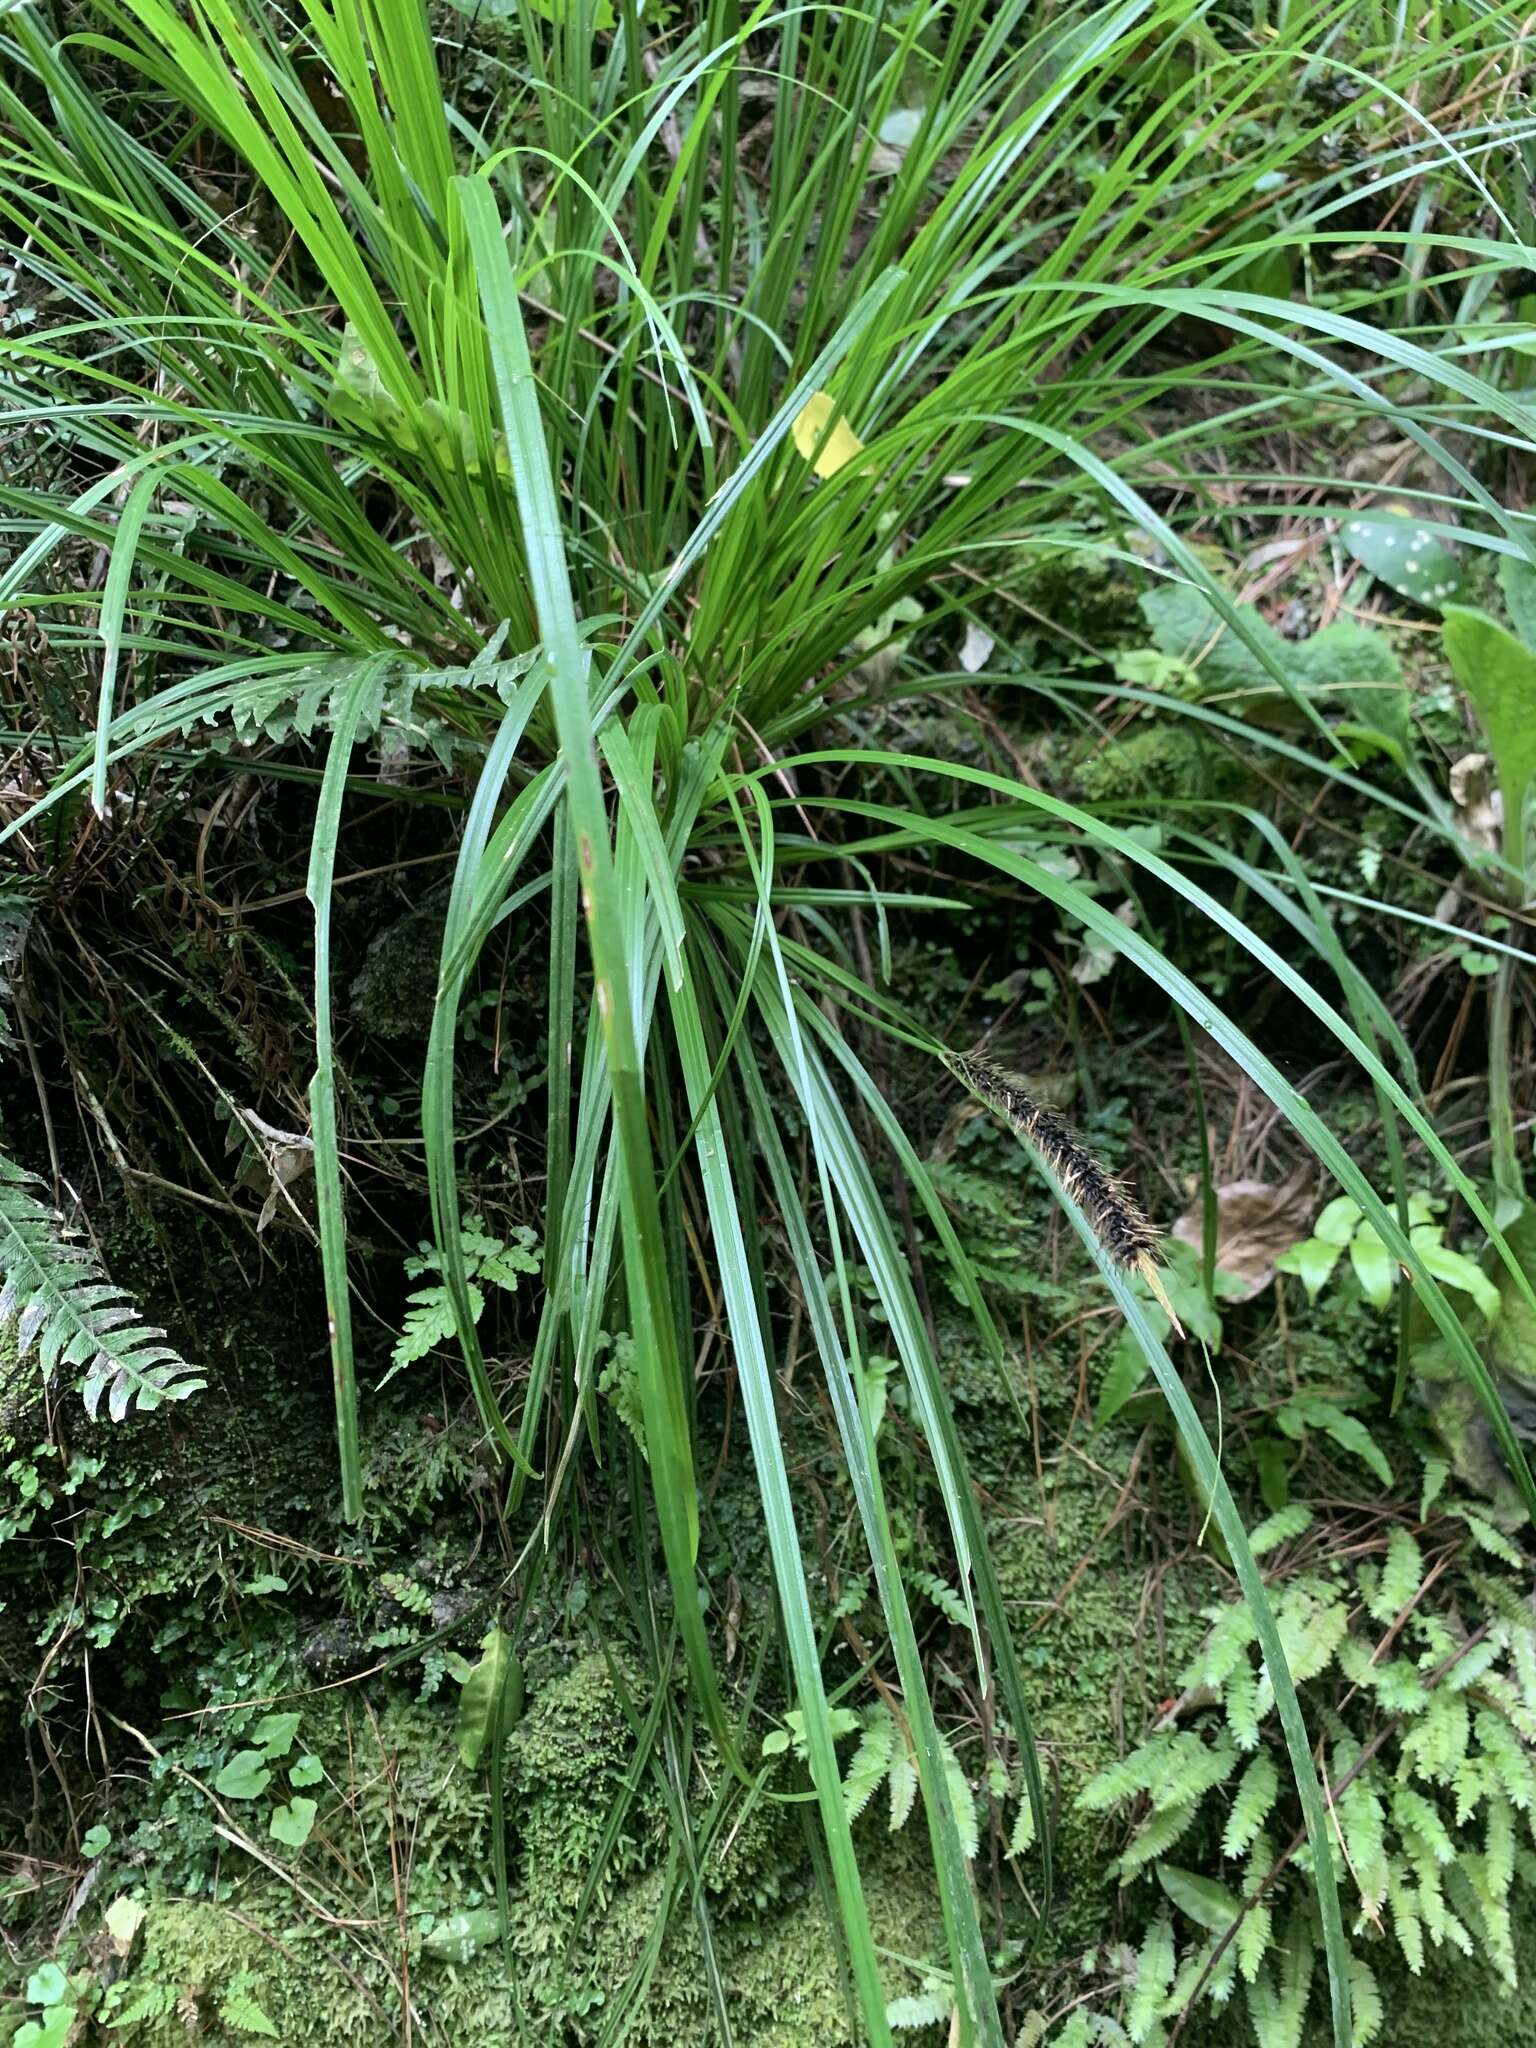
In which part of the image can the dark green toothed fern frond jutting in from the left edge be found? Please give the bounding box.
[0,1155,207,1421]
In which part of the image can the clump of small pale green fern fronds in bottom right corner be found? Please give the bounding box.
[1055,1501,1536,2048]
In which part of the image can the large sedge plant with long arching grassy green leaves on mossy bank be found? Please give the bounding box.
[0,0,1536,2048]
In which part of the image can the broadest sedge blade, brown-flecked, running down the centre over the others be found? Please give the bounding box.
[455,178,739,1767]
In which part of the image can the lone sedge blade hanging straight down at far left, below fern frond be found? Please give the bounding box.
[305,655,393,1522]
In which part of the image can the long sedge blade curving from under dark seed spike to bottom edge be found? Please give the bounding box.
[1030,1149,1352,2048]
